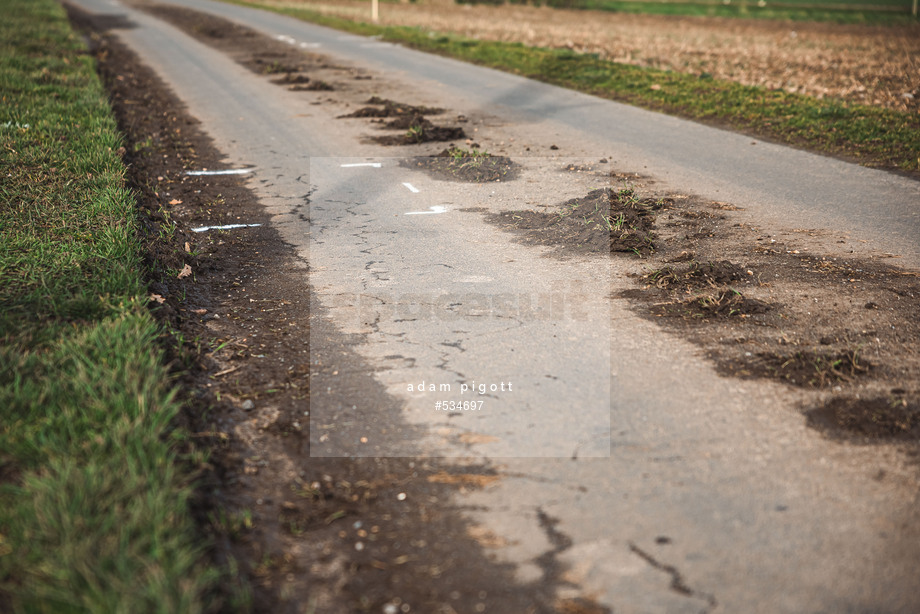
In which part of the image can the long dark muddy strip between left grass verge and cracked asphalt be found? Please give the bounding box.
[68,7,609,614]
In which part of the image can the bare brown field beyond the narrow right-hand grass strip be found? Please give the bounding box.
[278,0,920,112]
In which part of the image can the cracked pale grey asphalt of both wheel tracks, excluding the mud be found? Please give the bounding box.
[68,0,920,612]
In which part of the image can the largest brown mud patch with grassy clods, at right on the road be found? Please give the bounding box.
[486,168,920,446]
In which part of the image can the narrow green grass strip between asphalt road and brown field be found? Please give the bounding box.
[225,0,920,173]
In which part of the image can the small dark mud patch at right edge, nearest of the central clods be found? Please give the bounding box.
[805,394,920,441]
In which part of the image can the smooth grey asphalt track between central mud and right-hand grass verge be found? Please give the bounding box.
[127,0,920,266]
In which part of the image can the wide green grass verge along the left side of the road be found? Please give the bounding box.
[0,0,215,613]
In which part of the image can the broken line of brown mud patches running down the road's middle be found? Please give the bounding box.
[133,0,920,448]
